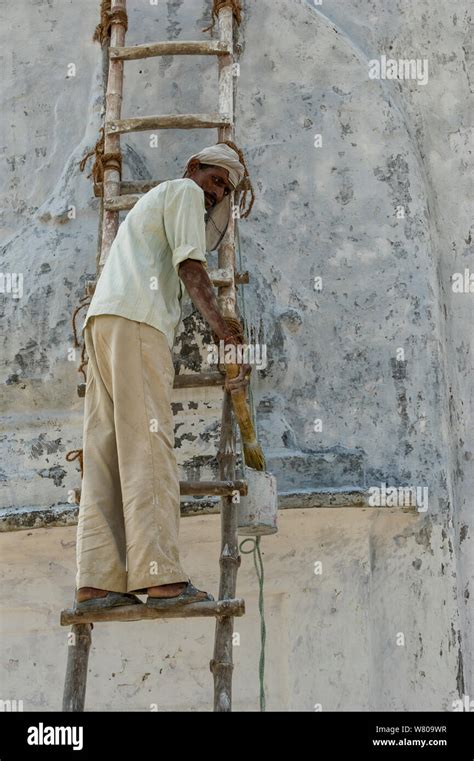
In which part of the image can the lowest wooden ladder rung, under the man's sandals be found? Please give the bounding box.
[60,598,245,626]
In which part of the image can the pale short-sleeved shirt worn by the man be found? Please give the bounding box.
[83,177,207,349]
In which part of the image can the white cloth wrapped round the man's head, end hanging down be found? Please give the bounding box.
[185,143,245,251]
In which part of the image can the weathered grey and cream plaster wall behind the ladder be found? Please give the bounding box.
[0,0,474,710]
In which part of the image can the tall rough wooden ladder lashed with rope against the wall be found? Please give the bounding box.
[60,0,248,711]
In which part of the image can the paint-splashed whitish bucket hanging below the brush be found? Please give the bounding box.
[237,466,278,536]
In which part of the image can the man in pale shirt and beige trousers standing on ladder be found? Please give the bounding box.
[75,143,251,611]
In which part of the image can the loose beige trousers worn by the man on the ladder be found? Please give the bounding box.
[76,314,189,594]
